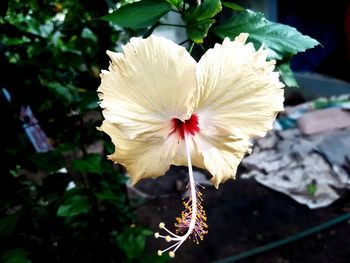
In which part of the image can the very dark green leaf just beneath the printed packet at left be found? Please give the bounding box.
[28,151,65,172]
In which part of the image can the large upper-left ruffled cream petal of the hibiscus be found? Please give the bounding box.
[98,36,196,141]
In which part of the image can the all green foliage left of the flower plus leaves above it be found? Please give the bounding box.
[0,0,318,263]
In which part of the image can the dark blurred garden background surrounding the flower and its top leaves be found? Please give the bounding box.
[0,0,350,263]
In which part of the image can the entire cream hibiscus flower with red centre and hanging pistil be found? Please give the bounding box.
[98,33,284,256]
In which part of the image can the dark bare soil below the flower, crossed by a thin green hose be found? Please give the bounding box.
[133,167,350,263]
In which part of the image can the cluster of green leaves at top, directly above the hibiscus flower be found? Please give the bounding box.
[103,0,319,87]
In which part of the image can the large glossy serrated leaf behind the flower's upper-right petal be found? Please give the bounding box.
[214,10,319,60]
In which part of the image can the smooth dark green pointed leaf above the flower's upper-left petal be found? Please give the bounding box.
[102,0,171,29]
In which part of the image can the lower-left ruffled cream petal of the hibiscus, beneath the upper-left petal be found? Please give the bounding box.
[99,120,178,185]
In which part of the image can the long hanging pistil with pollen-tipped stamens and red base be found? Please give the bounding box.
[154,134,208,257]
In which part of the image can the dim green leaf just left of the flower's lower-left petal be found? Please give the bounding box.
[72,154,102,174]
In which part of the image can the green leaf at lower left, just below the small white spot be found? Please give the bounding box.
[57,193,90,217]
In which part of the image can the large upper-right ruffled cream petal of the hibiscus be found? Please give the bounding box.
[195,34,284,138]
